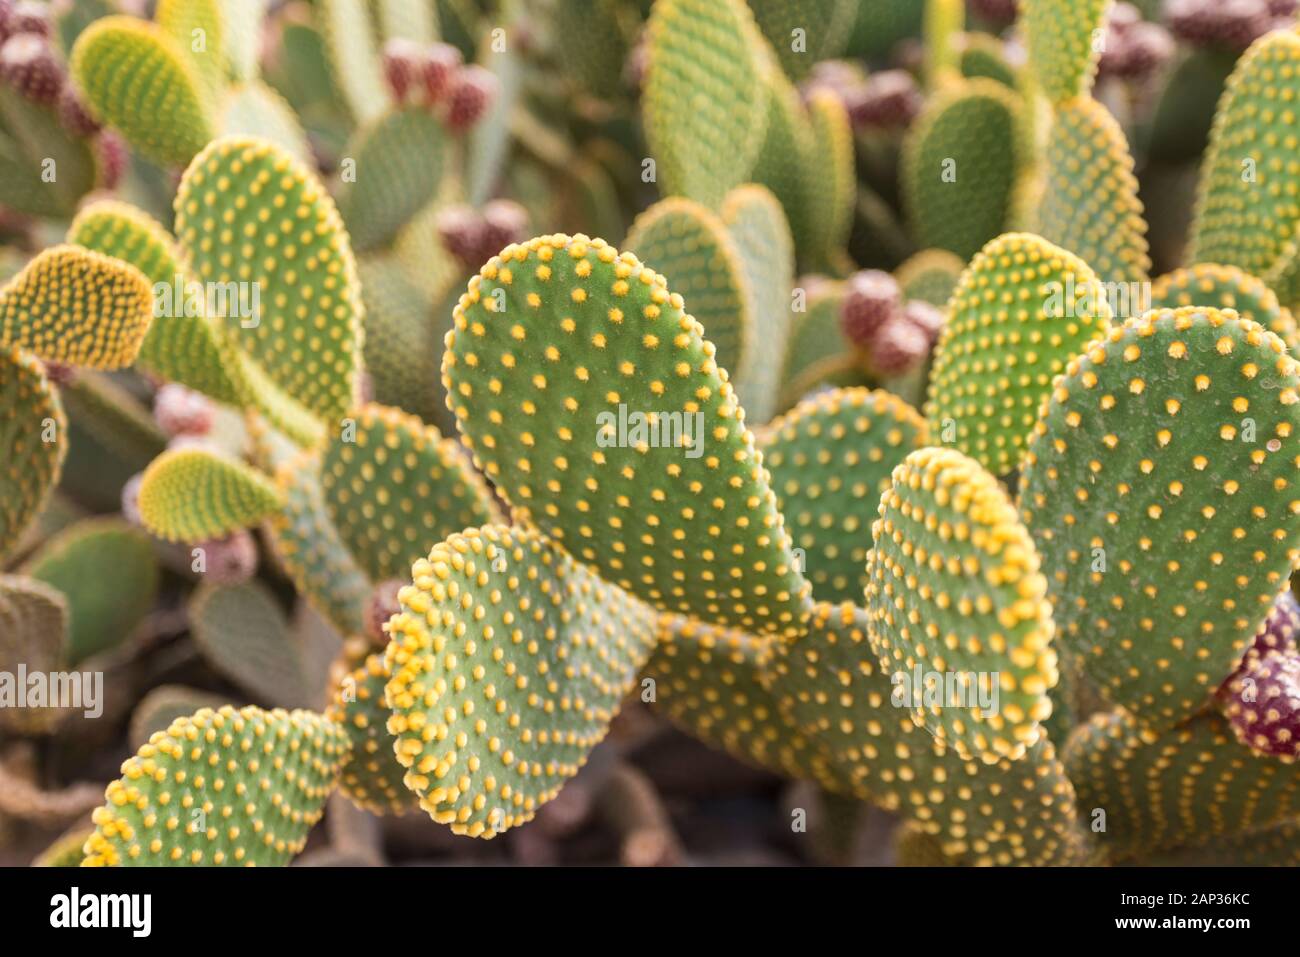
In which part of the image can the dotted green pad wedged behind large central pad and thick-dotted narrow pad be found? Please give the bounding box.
[759,389,928,603]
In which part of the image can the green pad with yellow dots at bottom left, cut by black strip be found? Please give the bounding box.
[82,706,348,867]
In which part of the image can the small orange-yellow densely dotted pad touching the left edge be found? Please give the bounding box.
[0,246,153,369]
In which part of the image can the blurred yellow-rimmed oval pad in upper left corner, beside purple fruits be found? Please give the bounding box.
[72,17,216,166]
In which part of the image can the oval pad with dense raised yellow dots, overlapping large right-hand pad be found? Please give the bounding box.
[866,449,1060,762]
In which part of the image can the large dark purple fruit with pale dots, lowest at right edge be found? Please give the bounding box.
[1218,650,1300,762]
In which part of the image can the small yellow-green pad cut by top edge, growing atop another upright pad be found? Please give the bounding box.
[1021,0,1110,103]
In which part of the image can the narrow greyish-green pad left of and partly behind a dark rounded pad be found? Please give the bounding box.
[268,451,374,635]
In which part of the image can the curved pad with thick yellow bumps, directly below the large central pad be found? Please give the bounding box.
[385,525,657,837]
